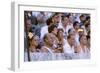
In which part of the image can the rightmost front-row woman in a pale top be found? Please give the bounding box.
[77,35,90,59]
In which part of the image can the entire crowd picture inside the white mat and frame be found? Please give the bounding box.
[24,11,91,61]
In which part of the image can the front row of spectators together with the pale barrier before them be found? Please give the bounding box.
[24,33,90,61]
